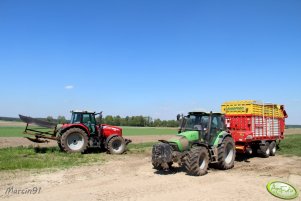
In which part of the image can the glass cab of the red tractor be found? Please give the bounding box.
[70,111,101,135]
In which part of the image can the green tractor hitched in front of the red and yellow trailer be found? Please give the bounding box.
[152,112,236,176]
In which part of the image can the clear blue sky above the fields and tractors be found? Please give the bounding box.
[0,0,301,124]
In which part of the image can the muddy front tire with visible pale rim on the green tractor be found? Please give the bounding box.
[185,146,209,176]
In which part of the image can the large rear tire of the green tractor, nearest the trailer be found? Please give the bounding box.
[215,137,236,170]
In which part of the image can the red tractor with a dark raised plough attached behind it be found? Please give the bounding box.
[19,111,131,154]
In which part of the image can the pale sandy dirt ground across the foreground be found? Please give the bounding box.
[0,153,301,201]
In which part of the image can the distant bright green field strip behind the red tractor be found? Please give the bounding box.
[0,126,177,137]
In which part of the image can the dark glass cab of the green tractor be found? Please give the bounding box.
[178,112,226,145]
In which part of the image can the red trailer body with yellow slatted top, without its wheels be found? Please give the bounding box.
[222,101,285,153]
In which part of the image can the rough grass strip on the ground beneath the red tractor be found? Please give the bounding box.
[0,143,154,171]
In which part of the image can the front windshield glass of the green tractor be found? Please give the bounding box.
[182,115,209,131]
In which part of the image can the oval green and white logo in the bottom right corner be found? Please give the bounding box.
[267,181,299,200]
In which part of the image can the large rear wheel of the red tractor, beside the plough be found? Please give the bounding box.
[60,128,88,153]
